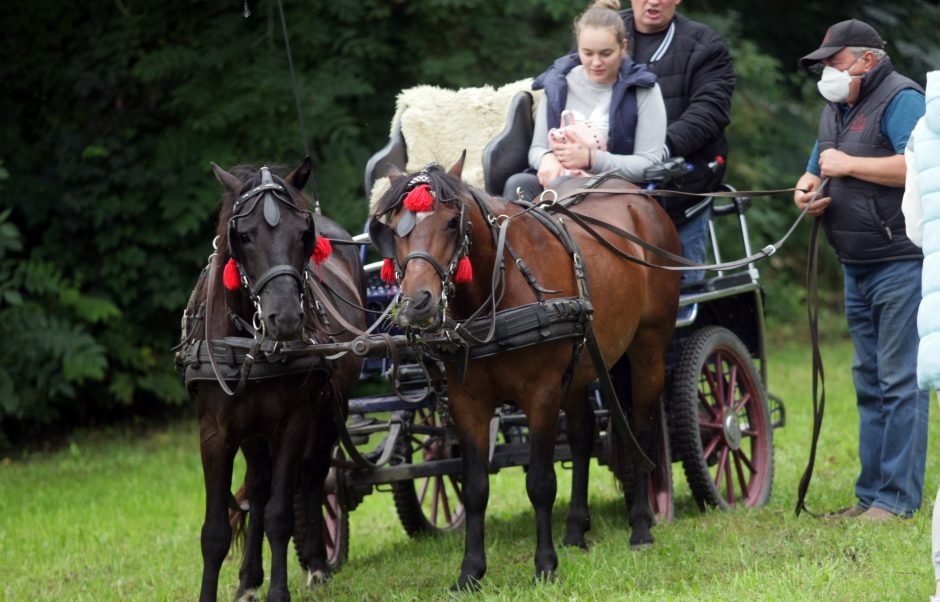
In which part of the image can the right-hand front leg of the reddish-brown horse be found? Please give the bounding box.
[525,391,559,581]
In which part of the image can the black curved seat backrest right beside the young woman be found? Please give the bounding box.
[483,92,535,196]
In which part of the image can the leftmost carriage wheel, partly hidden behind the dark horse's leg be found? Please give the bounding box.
[294,446,349,572]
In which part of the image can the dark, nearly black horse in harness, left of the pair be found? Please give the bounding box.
[177,157,365,601]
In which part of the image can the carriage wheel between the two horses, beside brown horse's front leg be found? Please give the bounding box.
[392,408,464,537]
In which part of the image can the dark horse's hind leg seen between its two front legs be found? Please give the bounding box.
[235,438,271,600]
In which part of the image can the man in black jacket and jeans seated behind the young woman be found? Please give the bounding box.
[622,0,735,283]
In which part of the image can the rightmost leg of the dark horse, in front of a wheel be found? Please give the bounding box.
[300,412,337,585]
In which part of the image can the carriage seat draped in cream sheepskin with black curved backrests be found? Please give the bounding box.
[363,79,542,206]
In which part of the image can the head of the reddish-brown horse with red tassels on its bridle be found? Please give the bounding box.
[369,157,472,330]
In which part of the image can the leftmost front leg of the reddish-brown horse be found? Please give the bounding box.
[450,389,493,591]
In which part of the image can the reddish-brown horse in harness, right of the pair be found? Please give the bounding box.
[370,157,679,590]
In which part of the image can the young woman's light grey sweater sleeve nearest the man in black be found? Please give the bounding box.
[596,84,666,182]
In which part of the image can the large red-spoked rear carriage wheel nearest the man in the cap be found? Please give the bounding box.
[669,326,773,510]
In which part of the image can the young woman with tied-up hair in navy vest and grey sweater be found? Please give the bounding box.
[503,0,666,200]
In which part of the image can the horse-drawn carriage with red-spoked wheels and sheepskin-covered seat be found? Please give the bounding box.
[308,84,785,568]
